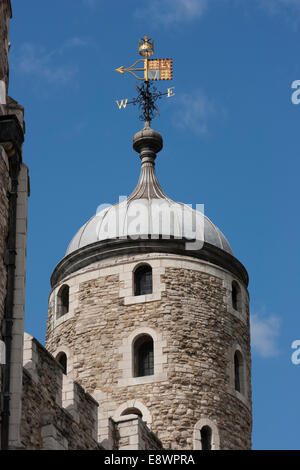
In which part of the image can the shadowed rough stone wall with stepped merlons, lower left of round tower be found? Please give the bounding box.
[21,334,101,450]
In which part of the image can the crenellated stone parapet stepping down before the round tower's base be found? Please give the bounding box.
[21,333,163,450]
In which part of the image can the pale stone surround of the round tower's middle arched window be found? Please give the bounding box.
[118,326,167,388]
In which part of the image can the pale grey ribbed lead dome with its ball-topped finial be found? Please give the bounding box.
[66,123,233,256]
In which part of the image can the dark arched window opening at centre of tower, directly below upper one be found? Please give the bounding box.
[133,335,154,377]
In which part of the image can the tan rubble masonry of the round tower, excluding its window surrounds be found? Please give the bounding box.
[47,255,252,449]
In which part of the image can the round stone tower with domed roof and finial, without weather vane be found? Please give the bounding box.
[46,123,252,450]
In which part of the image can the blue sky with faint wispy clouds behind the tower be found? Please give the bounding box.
[9,0,300,449]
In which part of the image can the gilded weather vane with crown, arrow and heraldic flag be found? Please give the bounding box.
[115,36,175,123]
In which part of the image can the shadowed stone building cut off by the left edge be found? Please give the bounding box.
[0,0,30,450]
